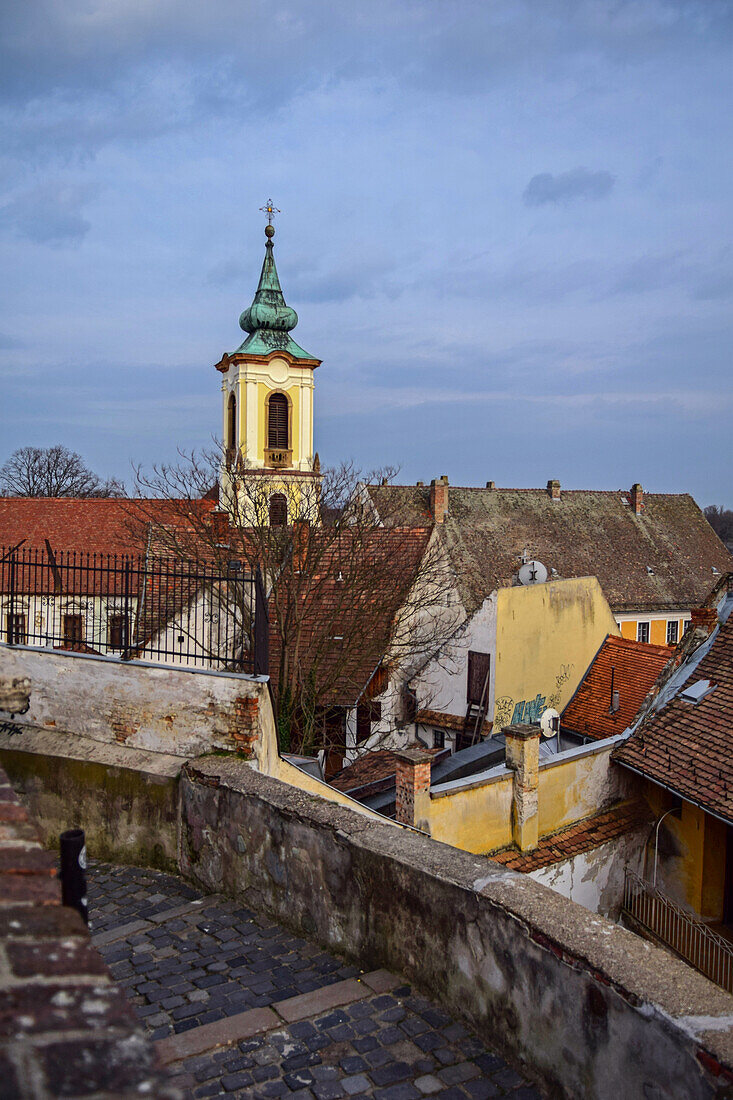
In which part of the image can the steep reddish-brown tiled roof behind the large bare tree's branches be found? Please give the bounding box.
[270,528,431,705]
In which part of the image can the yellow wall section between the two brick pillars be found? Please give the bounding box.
[418,774,512,853]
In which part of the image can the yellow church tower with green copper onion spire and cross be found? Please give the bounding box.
[211,211,320,526]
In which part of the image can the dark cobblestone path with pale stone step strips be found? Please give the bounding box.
[89,865,540,1100]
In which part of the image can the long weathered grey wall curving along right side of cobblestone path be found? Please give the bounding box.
[182,758,733,1100]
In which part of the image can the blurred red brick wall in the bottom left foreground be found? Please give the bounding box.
[0,771,183,1100]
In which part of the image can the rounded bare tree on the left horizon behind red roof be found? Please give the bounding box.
[0,443,124,496]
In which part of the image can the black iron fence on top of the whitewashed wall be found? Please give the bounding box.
[0,548,270,675]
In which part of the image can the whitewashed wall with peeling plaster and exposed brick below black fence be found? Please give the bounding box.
[0,645,272,757]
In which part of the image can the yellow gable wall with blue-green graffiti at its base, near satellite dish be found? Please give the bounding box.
[493,576,619,727]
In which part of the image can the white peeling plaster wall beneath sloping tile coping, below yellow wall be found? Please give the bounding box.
[529,829,648,921]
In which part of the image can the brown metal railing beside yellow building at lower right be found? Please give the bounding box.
[623,867,733,992]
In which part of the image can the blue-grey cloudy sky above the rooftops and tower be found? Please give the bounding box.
[0,0,733,507]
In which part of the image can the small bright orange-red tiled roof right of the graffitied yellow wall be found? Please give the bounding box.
[561,635,674,740]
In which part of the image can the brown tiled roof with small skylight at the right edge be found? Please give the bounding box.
[613,615,733,823]
